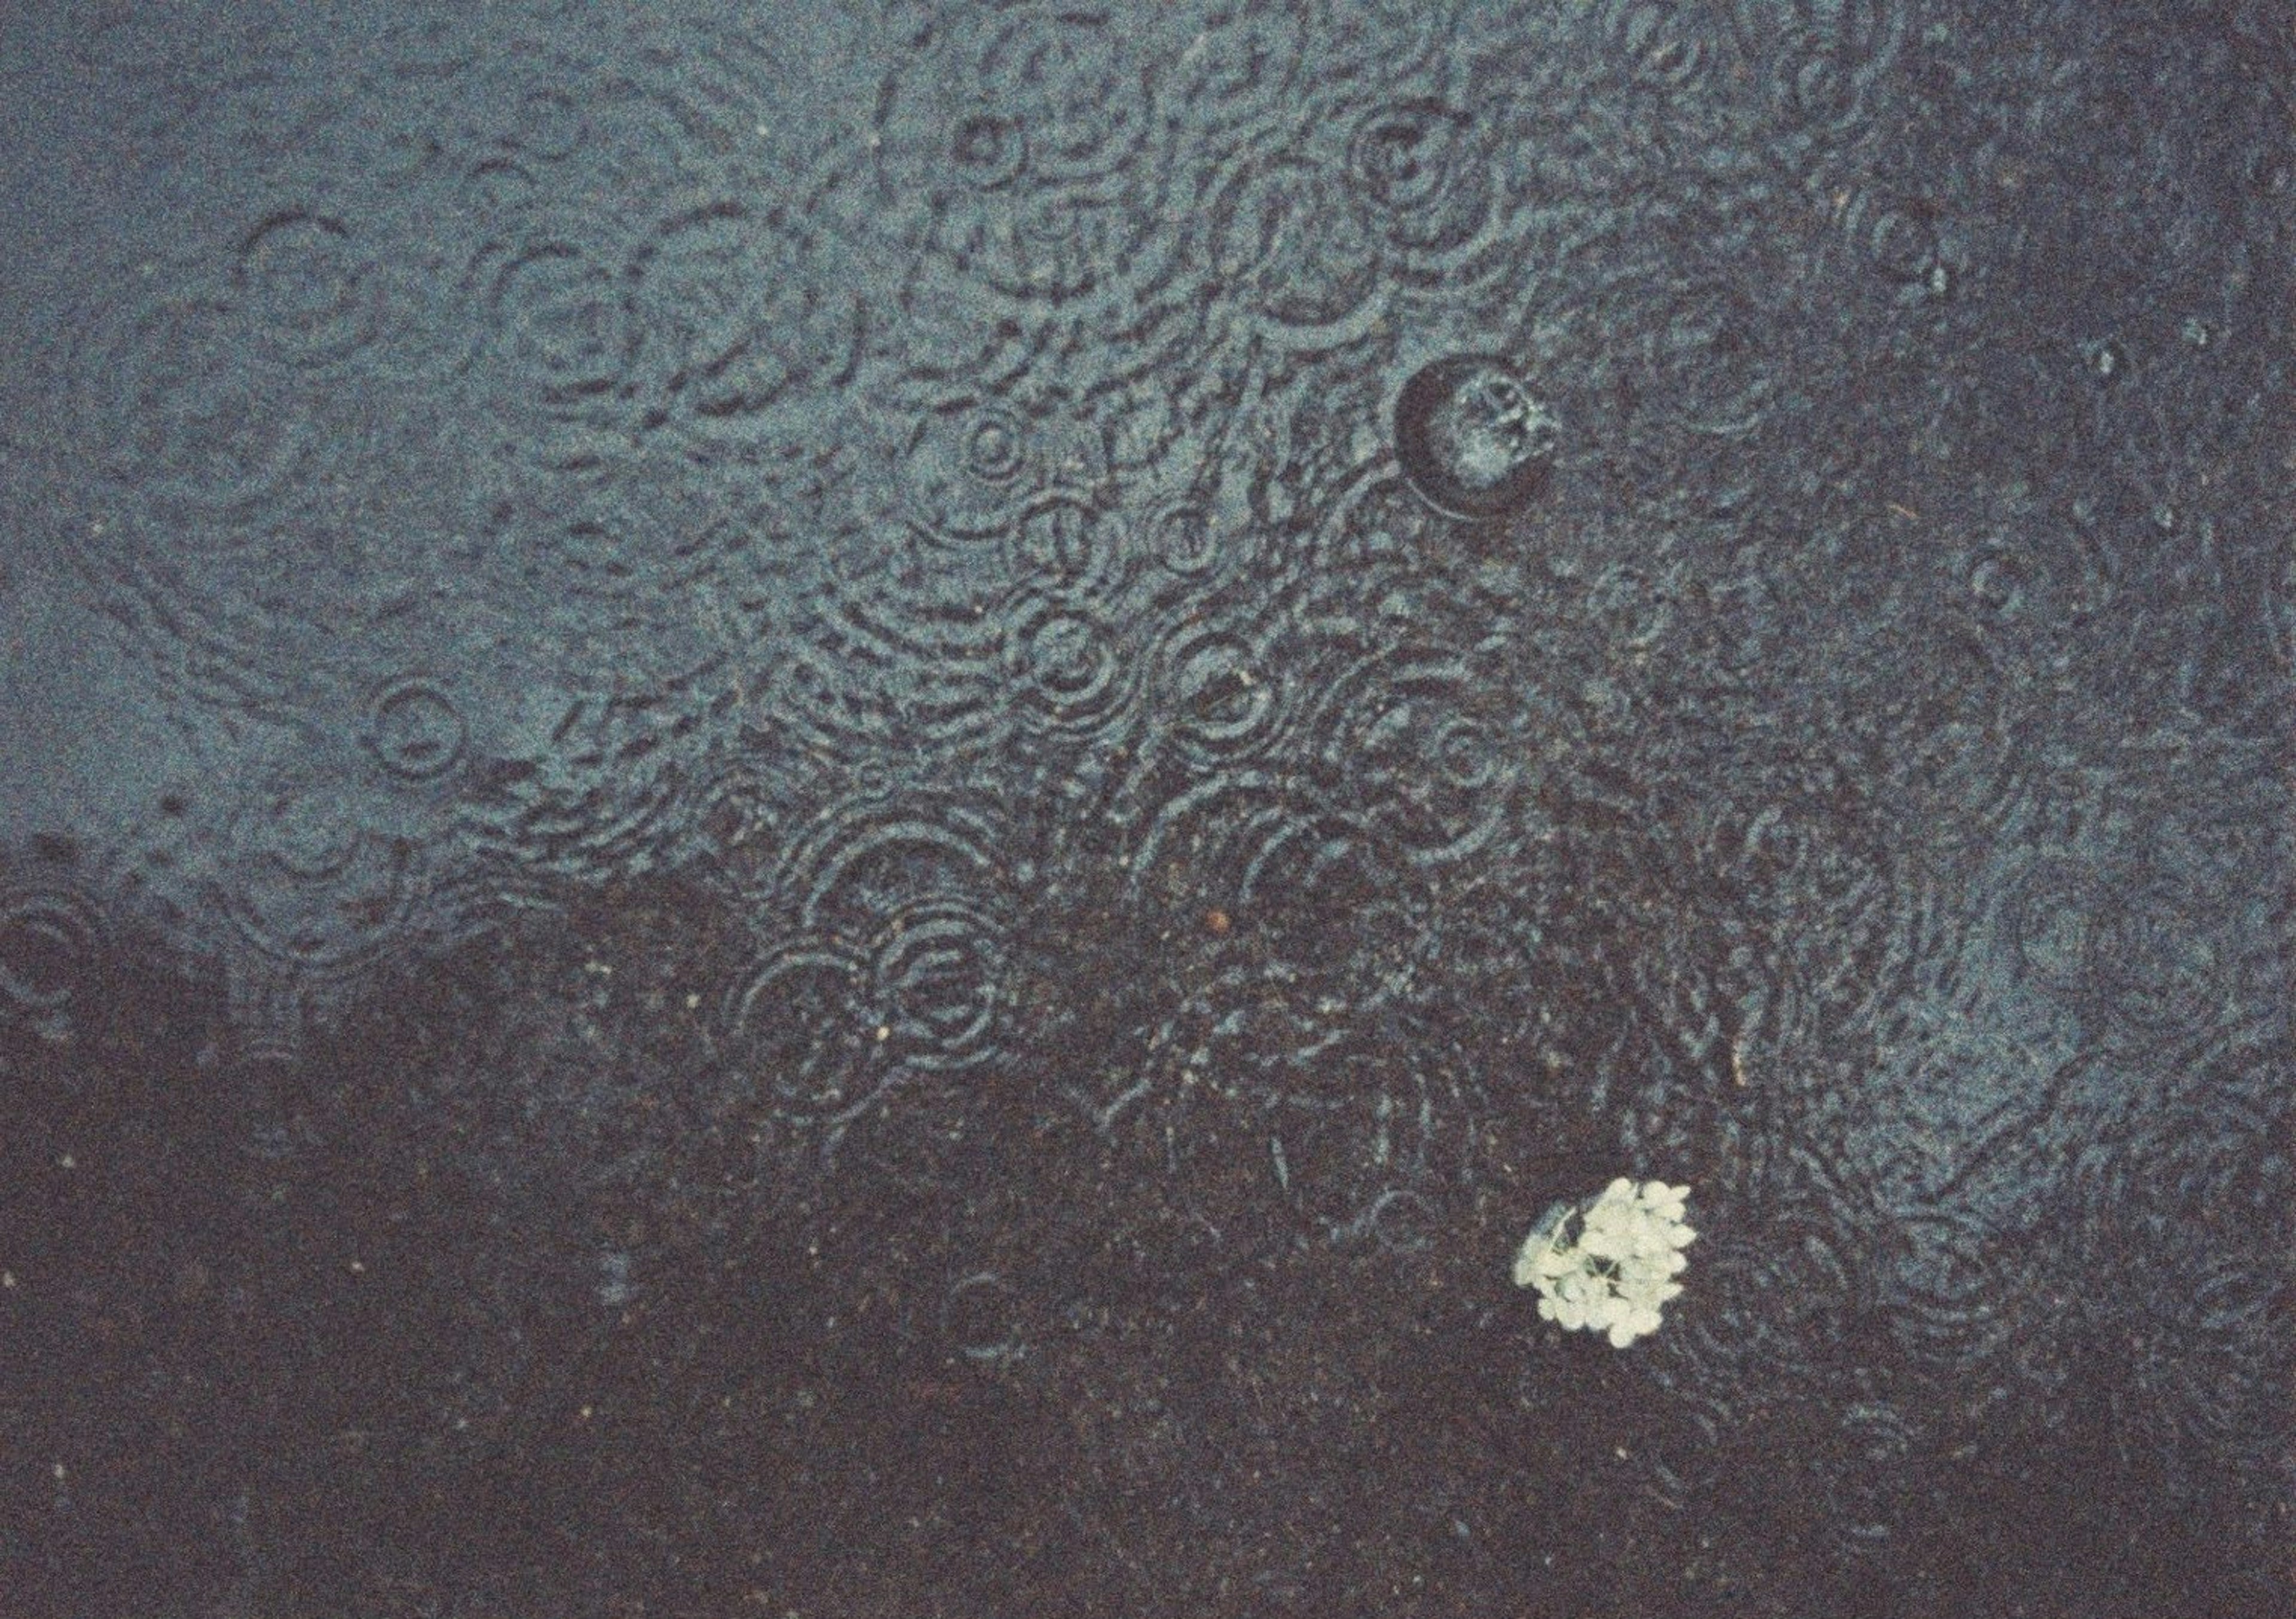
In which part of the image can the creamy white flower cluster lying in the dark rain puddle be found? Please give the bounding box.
[1515,1176,1697,1348]
